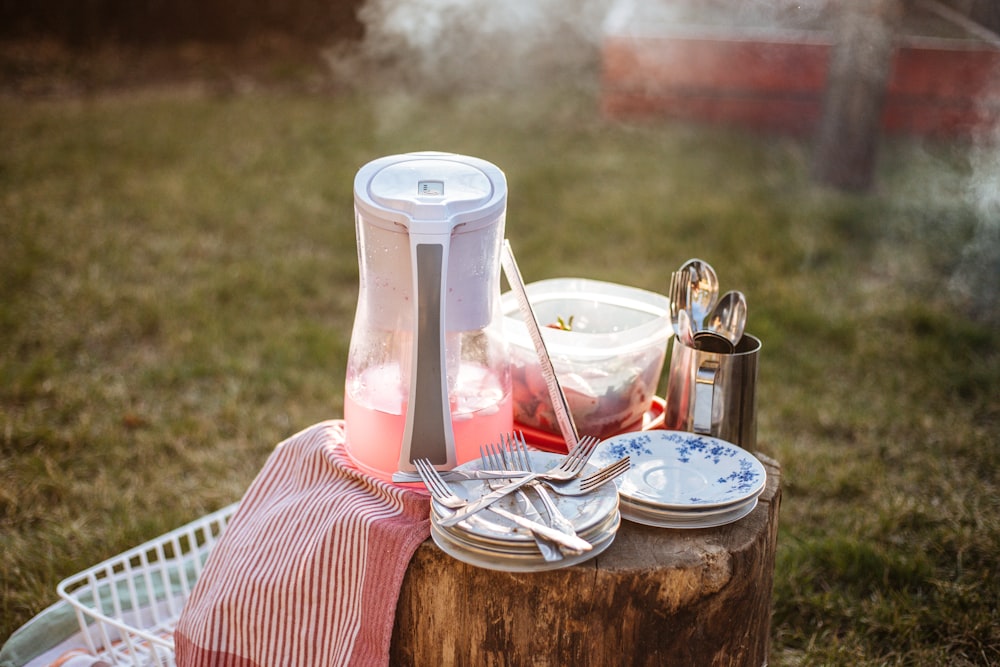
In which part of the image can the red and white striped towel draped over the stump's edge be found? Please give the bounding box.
[174,421,430,667]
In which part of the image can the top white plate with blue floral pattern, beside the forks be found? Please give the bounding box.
[590,431,767,510]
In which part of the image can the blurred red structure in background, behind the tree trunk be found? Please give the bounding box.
[602,1,1000,136]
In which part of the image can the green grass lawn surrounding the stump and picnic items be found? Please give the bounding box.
[0,83,1000,665]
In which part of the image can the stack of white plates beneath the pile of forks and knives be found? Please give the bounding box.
[431,451,621,572]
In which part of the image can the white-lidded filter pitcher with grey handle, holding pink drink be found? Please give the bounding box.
[344,152,513,479]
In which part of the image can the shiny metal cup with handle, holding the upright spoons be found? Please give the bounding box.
[664,334,761,452]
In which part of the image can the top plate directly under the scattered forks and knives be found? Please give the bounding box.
[432,451,618,545]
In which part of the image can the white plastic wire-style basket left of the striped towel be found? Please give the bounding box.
[57,503,238,667]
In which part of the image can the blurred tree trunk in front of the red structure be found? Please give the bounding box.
[812,0,903,191]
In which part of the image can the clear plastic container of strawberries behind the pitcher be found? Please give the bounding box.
[501,278,673,438]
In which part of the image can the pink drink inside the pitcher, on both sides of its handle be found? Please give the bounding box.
[344,364,514,480]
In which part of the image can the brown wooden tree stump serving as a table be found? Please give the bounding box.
[390,455,781,667]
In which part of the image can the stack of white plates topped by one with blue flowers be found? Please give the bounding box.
[590,431,767,528]
